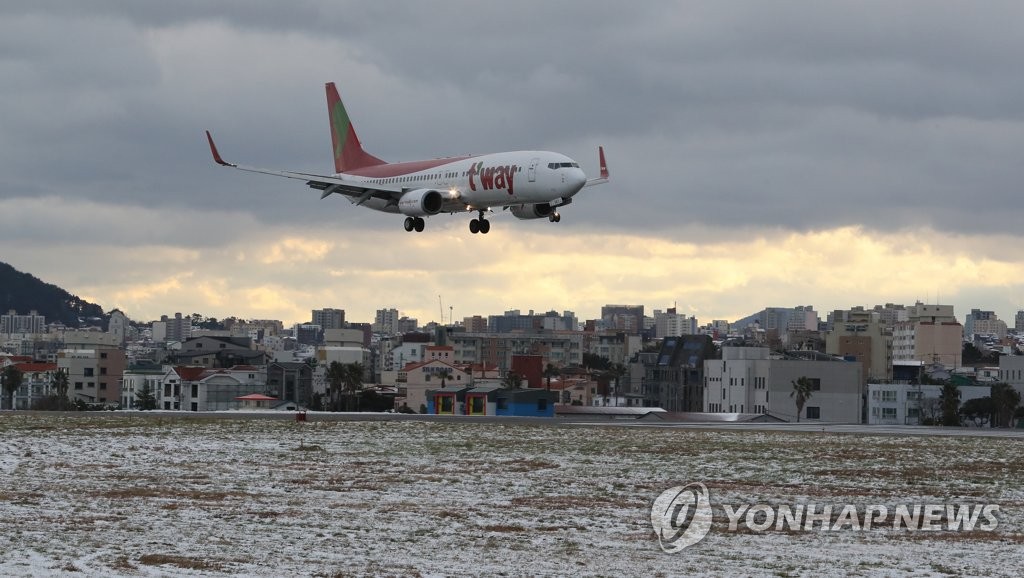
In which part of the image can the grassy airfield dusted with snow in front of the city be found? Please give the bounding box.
[0,412,1024,576]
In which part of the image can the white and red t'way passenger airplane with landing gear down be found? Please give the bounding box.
[206,82,608,235]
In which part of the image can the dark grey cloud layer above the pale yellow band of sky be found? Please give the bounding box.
[0,1,1024,239]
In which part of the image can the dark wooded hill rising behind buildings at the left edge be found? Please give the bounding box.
[0,261,106,327]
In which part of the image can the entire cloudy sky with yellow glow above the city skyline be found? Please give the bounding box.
[0,0,1024,326]
